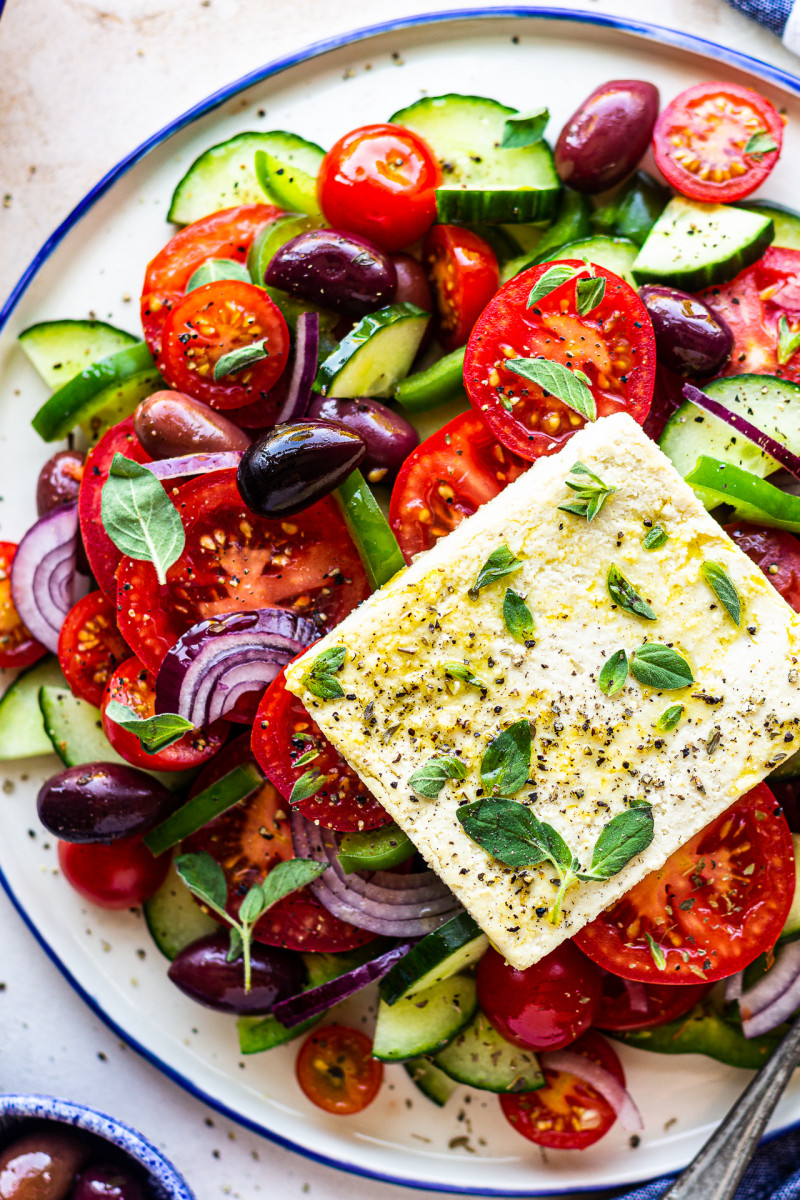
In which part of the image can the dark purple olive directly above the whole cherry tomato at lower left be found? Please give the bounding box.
[36,762,176,842]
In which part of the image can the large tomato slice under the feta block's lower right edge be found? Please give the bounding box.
[575,784,794,984]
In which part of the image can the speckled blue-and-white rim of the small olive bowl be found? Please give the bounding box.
[0,1094,196,1200]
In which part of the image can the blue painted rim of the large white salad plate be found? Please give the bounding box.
[0,11,800,1200]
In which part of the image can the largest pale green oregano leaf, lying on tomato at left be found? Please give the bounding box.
[101,454,186,583]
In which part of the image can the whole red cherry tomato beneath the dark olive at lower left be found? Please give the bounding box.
[59,838,169,908]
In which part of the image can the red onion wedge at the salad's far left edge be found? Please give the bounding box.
[11,500,89,654]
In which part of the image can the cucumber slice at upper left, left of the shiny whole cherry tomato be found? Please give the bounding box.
[167,130,323,224]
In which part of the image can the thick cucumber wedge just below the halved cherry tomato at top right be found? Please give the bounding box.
[633,196,775,292]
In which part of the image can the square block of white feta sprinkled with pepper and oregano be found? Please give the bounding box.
[287,414,800,968]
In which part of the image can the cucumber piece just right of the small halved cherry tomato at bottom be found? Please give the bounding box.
[372,976,477,1062]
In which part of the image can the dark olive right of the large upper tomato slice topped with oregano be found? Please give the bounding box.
[639,283,733,376]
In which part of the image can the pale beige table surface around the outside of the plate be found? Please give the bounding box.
[0,0,800,1200]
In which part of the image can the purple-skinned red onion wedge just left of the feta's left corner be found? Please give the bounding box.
[156,608,319,728]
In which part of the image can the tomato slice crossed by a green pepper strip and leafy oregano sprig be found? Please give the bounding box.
[181,733,375,953]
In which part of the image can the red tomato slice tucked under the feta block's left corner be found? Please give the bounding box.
[253,671,391,833]
